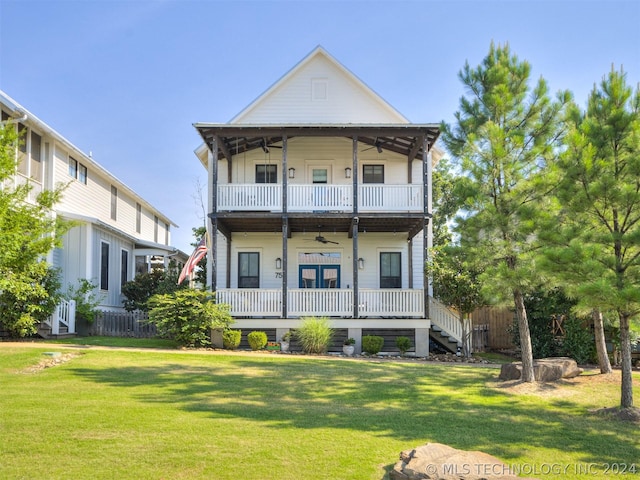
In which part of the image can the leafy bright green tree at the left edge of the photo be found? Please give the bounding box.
[0,122,69,337]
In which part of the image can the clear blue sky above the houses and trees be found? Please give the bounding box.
[0,0,640,253]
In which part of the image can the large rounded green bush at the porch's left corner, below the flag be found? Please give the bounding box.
[149,289,233,347]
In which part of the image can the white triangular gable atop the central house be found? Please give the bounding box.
[229,46,409,124]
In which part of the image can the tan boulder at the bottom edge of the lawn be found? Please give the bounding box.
[389,443,536,480]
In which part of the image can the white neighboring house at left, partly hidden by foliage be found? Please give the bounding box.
[0,91,187,334]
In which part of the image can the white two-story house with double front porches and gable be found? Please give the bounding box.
[194,47,459,355]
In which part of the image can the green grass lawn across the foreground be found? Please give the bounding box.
[0,344,640,480]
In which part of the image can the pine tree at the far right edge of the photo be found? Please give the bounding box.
[547,70,640,408]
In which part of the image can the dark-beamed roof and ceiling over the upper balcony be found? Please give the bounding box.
[194,123,440,160]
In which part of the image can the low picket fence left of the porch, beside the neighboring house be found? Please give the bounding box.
[85,311,158,338]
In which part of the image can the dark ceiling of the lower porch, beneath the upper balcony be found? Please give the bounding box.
[212,212,423,238]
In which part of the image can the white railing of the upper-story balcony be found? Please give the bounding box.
[217,183,423,212]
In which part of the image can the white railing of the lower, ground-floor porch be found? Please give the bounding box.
[216,288,424,318]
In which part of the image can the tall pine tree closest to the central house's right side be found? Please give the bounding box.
[442,43,569,382]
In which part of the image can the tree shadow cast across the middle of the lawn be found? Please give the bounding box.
[71,356,640,463]
